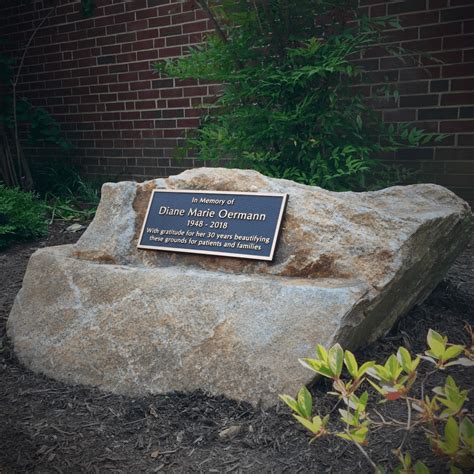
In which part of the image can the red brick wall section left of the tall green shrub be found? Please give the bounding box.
[0,0,218,179]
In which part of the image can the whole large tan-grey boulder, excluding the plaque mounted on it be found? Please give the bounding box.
[8,168,473,405]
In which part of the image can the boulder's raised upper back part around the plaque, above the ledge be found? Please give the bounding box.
[75,168,472,287]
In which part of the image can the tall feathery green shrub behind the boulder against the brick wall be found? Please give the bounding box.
[155,0,440,190]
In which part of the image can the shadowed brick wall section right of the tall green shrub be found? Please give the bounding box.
[360,0,474,203]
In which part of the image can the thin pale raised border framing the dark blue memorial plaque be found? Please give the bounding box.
[137,189,288,261]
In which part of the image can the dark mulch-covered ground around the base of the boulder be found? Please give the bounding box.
[0,224,474,473]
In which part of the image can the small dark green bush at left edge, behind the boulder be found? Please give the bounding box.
[0,184,48,249]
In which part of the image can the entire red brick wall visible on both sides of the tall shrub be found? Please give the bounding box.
[0,0,474,202]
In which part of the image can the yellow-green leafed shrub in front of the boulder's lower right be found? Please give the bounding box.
[280,326,474,474]
